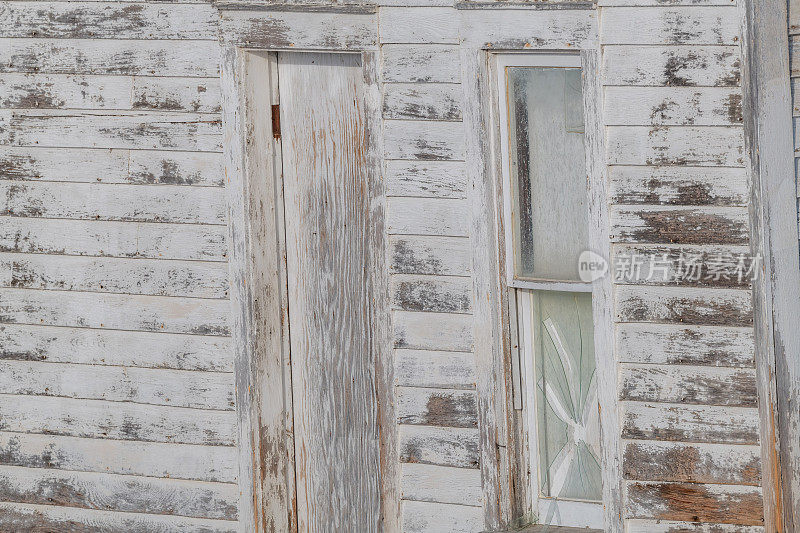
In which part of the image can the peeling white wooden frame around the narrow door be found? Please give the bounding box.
[218,5,399,533]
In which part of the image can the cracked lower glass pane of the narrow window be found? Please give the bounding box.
[518,291,602,501]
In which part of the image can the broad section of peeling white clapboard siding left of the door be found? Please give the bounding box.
[0,1,239,532]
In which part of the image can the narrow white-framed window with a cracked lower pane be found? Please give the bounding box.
[495,53,603,528]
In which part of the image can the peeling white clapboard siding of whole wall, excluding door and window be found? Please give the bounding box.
[0,0,776,533]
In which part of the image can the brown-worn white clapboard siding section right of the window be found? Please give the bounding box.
[599,0,763,532]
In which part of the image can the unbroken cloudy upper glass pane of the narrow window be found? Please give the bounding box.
[506,67,588,281]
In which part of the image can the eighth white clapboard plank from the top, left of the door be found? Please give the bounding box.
[0,252,228,298]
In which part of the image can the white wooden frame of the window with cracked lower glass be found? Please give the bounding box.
[492,52,604,529]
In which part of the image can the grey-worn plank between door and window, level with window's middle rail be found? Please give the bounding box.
[390,272,472,313]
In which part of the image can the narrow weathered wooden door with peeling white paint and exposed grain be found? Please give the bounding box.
[278,53,380,533]
